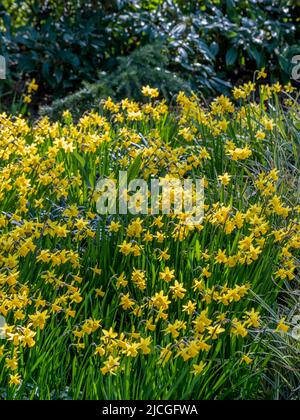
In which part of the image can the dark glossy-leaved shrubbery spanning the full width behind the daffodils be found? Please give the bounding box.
[0,0,300,110]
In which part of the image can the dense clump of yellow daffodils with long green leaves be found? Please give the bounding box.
[0,78,300,398]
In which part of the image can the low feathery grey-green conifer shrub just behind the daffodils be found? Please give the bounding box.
[40,44,190,119]
